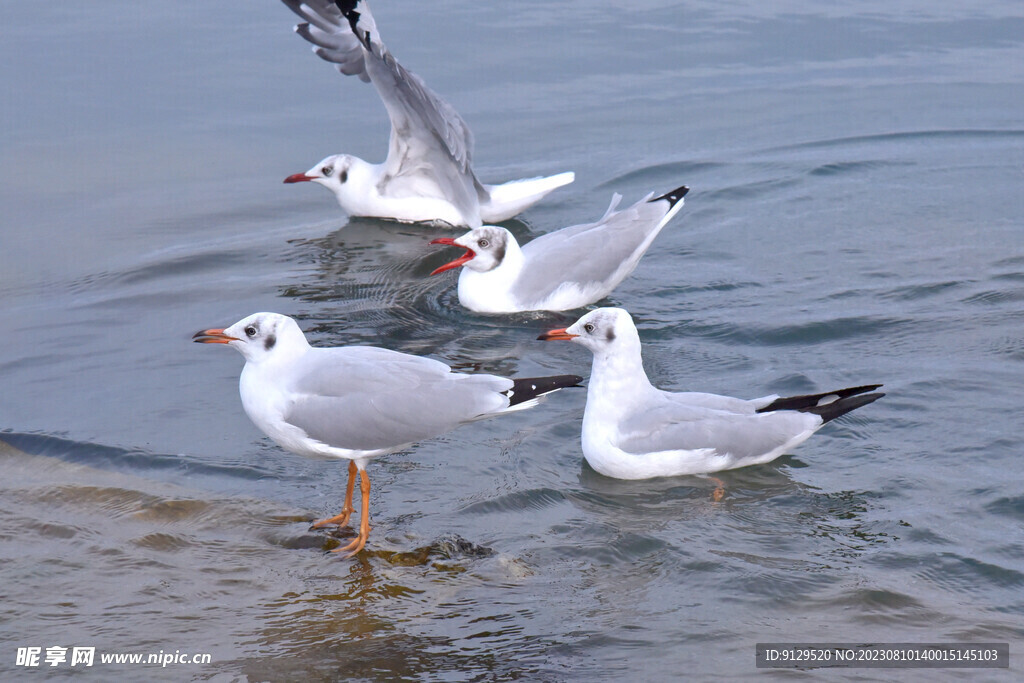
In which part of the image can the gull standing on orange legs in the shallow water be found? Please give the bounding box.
[193,312,583,557]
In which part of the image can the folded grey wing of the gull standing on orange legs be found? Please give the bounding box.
[285,347,512,451]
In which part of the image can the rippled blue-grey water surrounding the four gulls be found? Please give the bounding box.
[0,0,1024,681]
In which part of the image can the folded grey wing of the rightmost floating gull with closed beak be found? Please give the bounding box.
[618,405,821,460]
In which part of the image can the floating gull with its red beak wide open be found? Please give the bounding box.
[430,185,689,313]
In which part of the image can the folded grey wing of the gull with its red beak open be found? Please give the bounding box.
[515,189,682,300]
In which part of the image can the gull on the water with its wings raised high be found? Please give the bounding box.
[283,0,575,227]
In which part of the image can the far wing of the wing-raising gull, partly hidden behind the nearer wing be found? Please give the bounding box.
[282,0,376,83]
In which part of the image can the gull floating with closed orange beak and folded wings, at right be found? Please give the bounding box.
[539,308,885,479]
